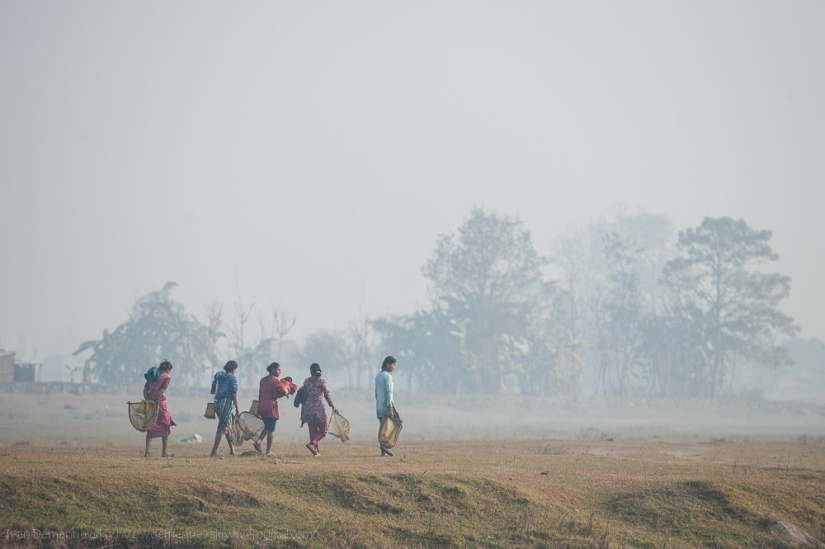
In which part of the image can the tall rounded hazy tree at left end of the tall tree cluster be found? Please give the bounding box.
[423,208,543,392]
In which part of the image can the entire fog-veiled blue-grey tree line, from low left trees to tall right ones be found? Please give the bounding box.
[75,208,798,398]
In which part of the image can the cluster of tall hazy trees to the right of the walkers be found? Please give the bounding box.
[373,209,798,398]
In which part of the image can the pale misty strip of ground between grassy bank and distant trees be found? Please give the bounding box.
[0,387,825,455]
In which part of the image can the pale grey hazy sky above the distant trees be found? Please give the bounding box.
[0,0,825,358]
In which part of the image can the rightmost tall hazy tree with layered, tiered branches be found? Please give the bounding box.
[663,217,798,397]
